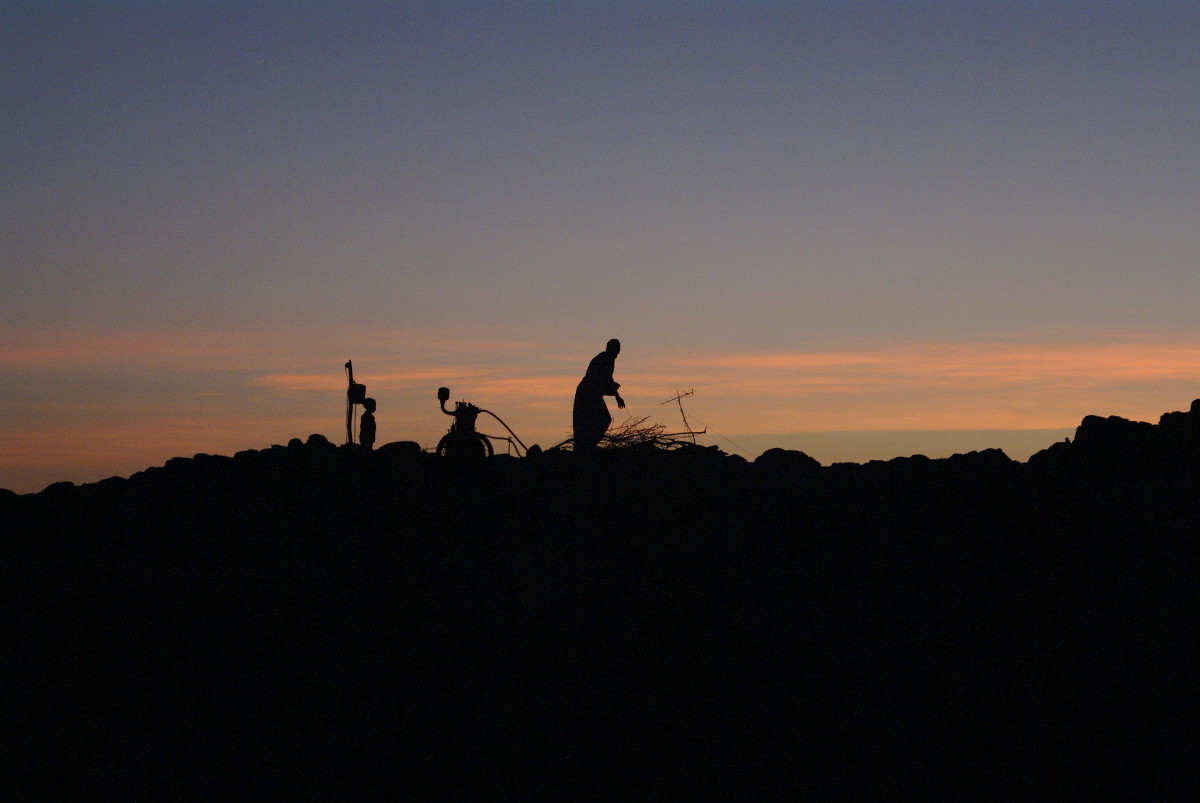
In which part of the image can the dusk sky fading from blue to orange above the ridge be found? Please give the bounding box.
[0,0,1200,492]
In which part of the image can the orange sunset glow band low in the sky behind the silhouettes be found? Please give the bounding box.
[0,330,1200,491]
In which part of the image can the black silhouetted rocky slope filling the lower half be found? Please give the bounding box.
[9,408,1200,797]
